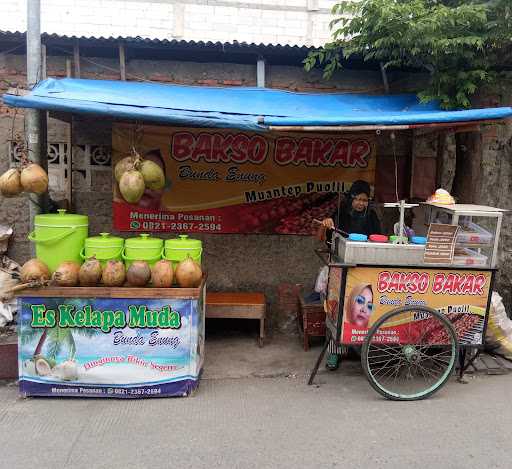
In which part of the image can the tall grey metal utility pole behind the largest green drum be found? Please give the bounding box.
[25,0,48,254]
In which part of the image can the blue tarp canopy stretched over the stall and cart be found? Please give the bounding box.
[3,78,512,132]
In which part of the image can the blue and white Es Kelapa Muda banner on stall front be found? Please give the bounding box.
[18,297,204,398]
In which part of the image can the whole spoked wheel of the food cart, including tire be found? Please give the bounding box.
[361,306,458,401]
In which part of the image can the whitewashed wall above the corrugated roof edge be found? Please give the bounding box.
[0,0,336,46]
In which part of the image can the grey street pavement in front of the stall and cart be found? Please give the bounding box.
[0,366,512,469]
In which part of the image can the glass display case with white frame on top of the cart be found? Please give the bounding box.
[425,203,505,268]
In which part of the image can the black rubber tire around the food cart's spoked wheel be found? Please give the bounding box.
[361,306,459,401]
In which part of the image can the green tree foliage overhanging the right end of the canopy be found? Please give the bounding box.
[304,0,512,109]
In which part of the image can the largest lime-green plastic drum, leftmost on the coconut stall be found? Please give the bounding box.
[28,209,89,272]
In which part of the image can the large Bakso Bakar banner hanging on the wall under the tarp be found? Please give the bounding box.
[112,124,375,235]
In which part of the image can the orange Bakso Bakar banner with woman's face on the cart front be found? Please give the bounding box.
[326,267,492,345]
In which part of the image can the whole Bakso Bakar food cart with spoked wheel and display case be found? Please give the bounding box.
[309,203,504,400]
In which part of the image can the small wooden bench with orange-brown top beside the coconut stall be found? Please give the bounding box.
[206,292,266,347]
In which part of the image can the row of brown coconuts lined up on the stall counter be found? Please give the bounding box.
[20,256,203,288]
